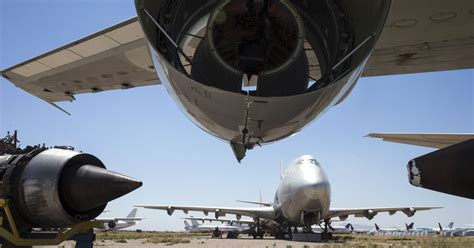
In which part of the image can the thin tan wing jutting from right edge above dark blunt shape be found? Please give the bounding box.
[366,133,474,149]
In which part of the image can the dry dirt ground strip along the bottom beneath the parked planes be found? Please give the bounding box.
[32,235,474,248]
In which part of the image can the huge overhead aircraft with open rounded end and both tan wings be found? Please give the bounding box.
[1,0,474,161]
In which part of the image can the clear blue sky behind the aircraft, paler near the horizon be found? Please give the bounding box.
[0,0,474,230]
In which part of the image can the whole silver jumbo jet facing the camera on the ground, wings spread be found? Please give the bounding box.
[137,155,438,238]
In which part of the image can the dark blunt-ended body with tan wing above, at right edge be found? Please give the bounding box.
[367,133,474,199]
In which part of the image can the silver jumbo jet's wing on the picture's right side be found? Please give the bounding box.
[324,207,441,220]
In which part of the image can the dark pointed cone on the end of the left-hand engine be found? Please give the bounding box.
[60,165,142,211]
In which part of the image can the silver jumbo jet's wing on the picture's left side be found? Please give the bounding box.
[135,205,275,219]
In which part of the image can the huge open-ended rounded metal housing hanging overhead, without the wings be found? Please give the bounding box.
[135,0,391,160]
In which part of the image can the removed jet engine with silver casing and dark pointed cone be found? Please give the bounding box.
[0,147,142,234]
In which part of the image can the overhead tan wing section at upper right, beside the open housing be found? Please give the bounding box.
[363,0,474,76]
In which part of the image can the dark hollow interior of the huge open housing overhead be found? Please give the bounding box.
[136,0,390,97]
